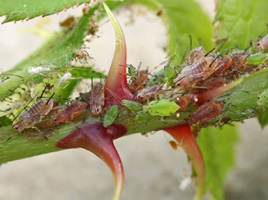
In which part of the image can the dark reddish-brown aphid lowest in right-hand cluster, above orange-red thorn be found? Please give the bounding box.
[188,101,224,124]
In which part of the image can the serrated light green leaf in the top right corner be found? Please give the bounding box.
[215,0,268,50]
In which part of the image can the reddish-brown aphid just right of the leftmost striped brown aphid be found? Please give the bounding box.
[53,100,87,124]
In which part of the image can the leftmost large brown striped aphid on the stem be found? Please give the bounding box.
[13,98,54,132]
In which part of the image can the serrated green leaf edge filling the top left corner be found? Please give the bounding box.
[0,0,90,23]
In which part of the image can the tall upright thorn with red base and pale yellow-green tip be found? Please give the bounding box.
[103,3,134,107]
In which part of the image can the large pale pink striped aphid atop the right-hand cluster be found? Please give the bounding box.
[173,57,218,86]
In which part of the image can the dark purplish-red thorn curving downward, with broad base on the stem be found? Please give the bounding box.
[56,122,127,200]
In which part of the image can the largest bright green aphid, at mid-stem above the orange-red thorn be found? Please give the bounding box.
[143,99,180,117]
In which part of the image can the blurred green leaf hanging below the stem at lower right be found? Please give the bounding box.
[197,126,238,200]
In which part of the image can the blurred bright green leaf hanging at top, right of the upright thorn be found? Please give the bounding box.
[126,0,213,64]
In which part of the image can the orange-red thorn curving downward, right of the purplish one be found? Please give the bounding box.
[163,124,206,200]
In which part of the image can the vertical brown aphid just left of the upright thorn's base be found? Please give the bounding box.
[90,83,104,116]
